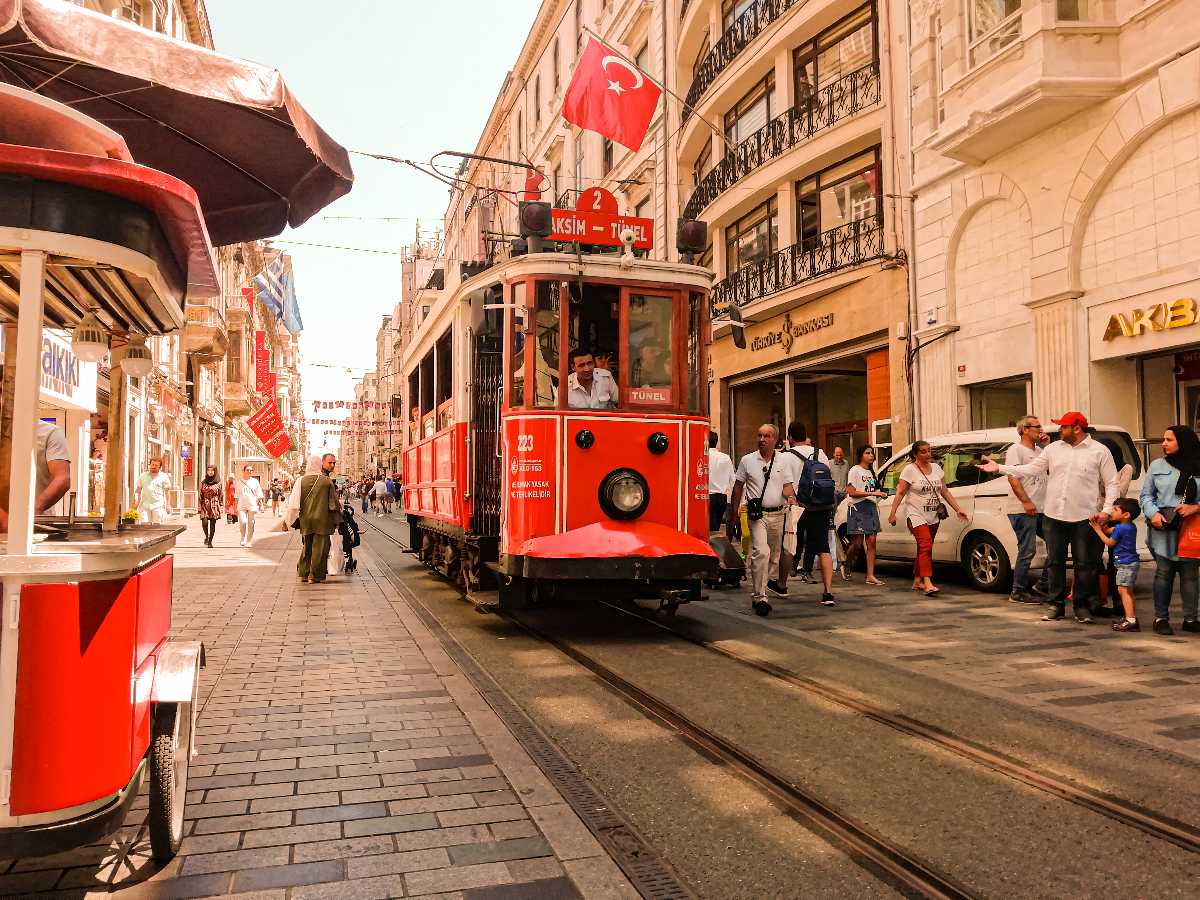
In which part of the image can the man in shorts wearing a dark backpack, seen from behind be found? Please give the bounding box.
[773,422,838,606]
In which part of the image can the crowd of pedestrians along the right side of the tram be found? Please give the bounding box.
[708,412,1200,635]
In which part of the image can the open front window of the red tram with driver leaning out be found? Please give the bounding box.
[566,282,620,409]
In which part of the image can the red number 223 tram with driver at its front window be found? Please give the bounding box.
[402,211,718,610]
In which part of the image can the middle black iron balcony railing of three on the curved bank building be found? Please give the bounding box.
[683,62,880,218]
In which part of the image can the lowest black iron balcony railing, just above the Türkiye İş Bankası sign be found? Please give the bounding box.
[710,216,883,317]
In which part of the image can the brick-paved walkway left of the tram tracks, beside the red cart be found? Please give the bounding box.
[0,516,637,900]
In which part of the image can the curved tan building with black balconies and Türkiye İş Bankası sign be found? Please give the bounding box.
[667,0,908,456]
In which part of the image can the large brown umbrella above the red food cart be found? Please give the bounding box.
[0,0,354,245]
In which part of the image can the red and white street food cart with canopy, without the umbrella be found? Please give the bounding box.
[0,103,217,858]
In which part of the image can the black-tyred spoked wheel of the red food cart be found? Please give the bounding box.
[146,703,192,860]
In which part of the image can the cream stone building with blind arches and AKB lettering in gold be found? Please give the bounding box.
[910,0,1200,455]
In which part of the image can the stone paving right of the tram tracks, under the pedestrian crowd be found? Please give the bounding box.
[703,564,1200,761]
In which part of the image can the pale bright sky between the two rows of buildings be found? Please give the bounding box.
[208,0,540,450]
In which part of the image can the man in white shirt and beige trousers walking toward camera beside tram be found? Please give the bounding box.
[726,422,799,616]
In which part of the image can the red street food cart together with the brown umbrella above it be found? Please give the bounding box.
[0,0,353,859]
